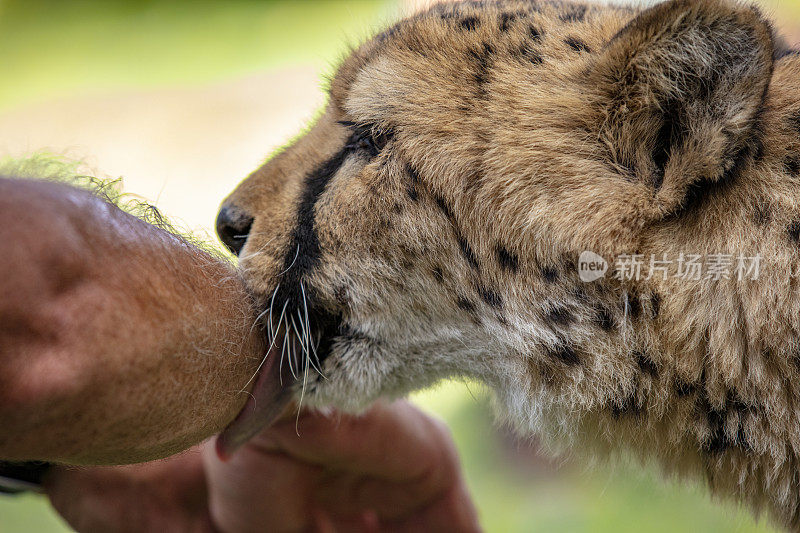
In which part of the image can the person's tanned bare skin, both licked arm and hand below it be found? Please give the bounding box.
[0,178,479,532]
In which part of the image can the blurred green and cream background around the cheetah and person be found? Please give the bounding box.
[0,0,800,533]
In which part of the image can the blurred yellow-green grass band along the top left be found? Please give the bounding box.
[0,0,392,110]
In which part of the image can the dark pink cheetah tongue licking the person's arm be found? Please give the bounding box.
[217,342,292,461]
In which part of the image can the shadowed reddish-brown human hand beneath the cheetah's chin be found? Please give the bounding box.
[45,401,479,532]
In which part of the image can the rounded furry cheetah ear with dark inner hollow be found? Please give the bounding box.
[589,0,774,218]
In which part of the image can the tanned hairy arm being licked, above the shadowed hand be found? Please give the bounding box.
[0,179,264,464]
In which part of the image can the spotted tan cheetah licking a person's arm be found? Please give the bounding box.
[217,0,800,530]
